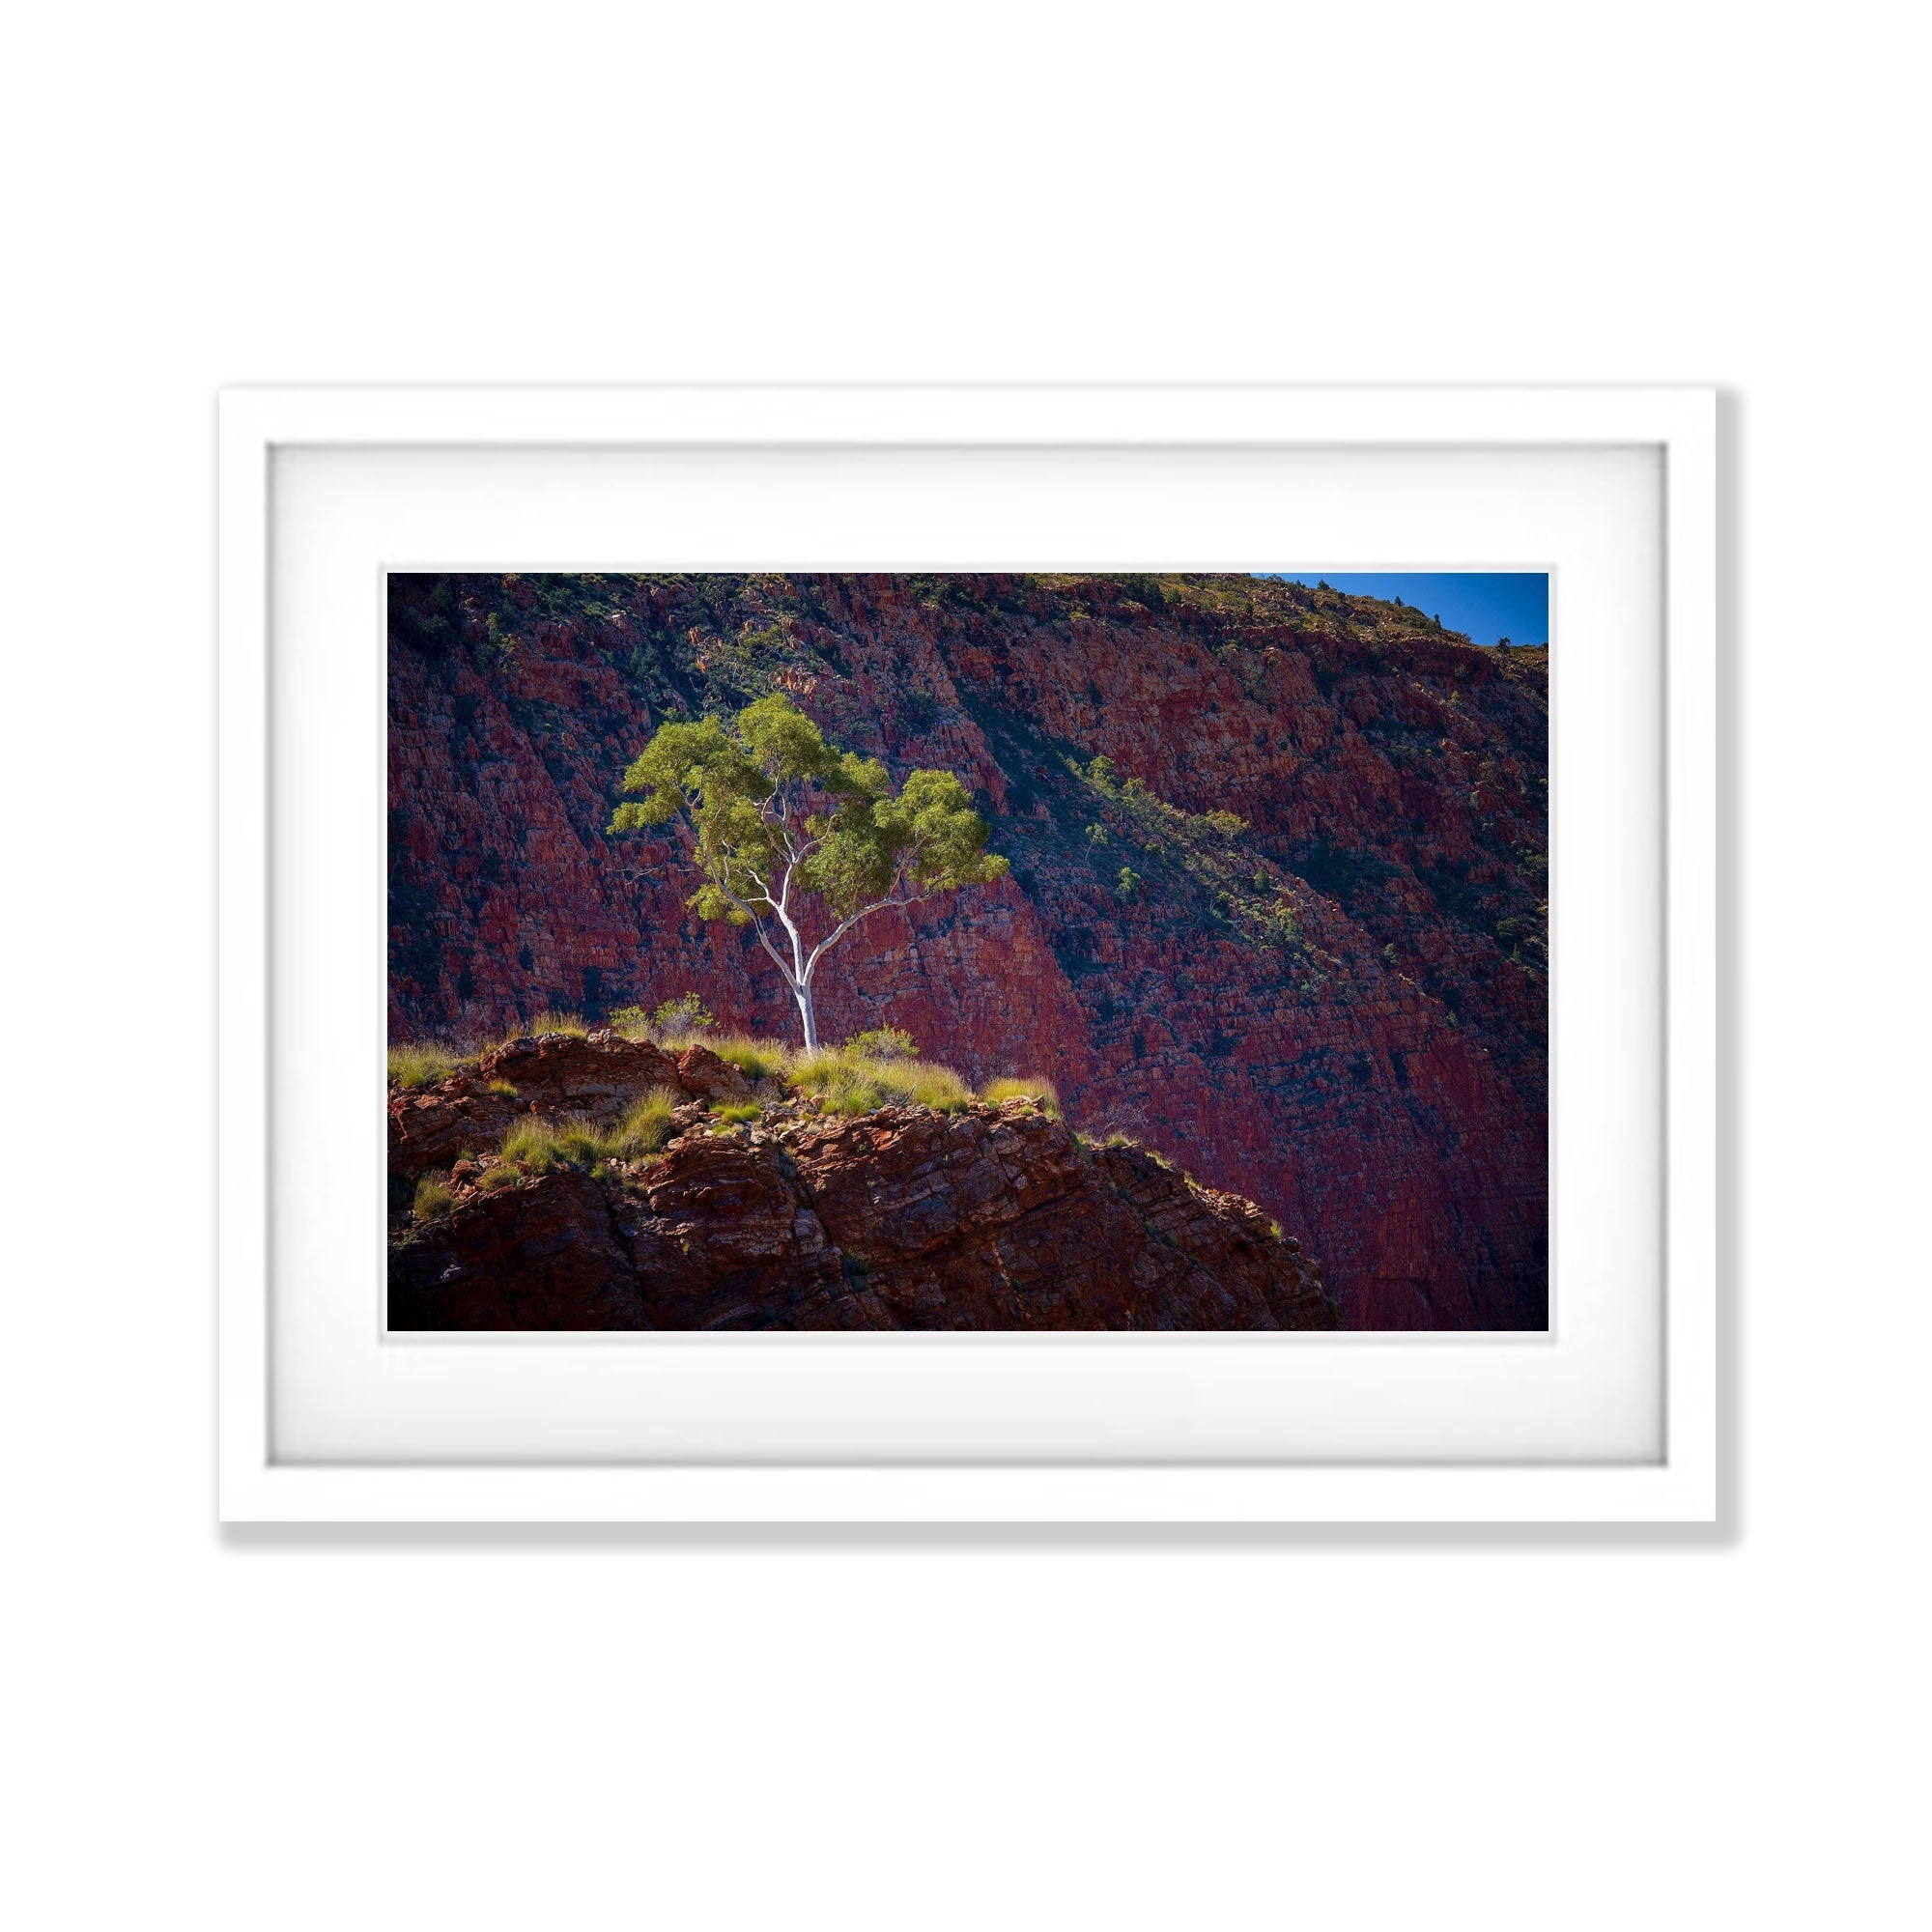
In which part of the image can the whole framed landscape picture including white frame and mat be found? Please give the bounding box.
[218,388,1718,1522]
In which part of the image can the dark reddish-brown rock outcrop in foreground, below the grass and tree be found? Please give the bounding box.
[390,1094,1339,1329]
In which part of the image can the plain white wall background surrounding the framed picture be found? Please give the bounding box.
[0,0,1932,1928]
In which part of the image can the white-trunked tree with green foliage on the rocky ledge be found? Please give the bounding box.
[611,692,1007,1051]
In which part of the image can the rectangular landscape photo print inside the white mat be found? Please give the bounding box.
[386,572,1549,1331]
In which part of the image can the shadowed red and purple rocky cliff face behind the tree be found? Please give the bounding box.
[390,576,1548,1327]
